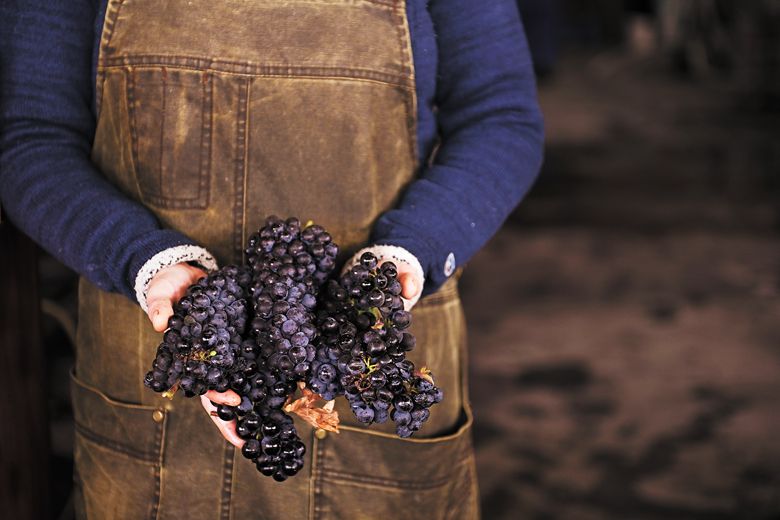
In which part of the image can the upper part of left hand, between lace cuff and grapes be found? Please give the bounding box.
[146,263,206,332]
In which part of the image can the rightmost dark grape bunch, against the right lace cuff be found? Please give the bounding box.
[308,252,443,437]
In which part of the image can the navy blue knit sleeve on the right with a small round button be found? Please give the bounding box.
[372,0,543,293]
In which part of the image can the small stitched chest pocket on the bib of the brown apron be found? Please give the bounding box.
[127,67,212,209]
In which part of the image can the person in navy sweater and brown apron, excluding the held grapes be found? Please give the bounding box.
[0,0,543,519]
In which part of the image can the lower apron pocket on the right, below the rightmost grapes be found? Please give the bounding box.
[314,407,479,520]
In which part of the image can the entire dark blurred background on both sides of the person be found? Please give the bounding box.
[0,0,780,520]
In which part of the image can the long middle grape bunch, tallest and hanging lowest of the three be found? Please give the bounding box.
[217,217,338,481]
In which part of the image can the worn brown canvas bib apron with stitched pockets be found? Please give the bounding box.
[71,0,479,520]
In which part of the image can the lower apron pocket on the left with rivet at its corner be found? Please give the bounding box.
[70,372,166,518]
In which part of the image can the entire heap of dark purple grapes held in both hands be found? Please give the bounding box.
[144,216,442,481]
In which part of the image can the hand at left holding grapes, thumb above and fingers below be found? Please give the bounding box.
[146,262,245,448]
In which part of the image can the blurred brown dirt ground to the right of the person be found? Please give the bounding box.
[461,49,780,520]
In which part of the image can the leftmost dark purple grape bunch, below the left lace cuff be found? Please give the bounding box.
[144,265,251,397]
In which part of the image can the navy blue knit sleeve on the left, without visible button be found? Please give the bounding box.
[0,0,201,299]
